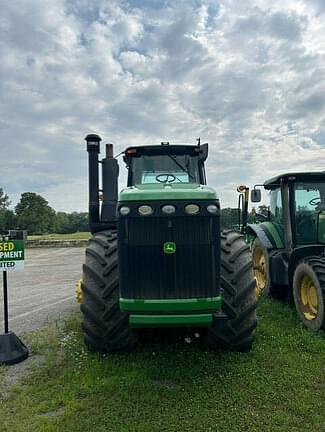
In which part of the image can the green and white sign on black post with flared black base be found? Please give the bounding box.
[0,231,29,365]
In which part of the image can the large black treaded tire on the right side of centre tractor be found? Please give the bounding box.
[207,230,257,351]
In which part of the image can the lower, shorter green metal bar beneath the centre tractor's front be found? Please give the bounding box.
[129,314,212,327]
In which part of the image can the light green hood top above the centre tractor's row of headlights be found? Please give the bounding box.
[119,183,218,201]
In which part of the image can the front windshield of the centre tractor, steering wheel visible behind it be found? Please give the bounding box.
[129,154,200,186]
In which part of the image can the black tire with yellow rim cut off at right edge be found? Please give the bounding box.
[292,257,325,330]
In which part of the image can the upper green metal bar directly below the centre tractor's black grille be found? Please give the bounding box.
[120,296,221,313]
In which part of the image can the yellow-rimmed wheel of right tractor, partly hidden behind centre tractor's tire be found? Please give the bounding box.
[252,238,289,300]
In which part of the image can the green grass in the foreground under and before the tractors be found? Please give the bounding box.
[0,299,325,432]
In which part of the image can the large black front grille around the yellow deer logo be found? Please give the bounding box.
[119,215,220,299]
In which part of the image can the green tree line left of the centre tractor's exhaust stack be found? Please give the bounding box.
[0,188,89,234]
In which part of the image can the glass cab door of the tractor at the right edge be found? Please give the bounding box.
[294,182,325,244]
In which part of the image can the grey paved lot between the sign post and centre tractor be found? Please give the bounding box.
[0,247,85,335]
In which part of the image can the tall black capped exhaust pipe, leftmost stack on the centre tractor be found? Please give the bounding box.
[85,134,102,232]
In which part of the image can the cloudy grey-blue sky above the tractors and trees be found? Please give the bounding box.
[0,0,325,212]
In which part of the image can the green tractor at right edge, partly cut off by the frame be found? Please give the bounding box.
[240,172,325,330]
